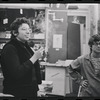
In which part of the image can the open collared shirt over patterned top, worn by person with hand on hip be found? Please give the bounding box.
[69,54,100,96]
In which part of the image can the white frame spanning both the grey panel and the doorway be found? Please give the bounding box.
[45,8,90,55]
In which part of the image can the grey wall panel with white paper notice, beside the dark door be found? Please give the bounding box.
[47,4,67,63]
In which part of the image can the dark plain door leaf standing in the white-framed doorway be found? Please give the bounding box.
[67,22,81,59]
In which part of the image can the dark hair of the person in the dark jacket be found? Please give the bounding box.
[10,17,31,38]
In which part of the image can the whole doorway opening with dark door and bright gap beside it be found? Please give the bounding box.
[67,13,86,59]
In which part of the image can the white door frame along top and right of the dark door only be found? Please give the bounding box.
[67,10,90,55]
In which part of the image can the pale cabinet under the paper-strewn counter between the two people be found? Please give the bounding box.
[45,63,72,96]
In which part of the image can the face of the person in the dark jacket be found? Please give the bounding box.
[17,23,31,42]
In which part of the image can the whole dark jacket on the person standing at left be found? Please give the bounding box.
[1,39,41,97]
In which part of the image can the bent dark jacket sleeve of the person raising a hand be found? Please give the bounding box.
[1,45,34,79]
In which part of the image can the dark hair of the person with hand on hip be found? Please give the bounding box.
[88,34,100,52]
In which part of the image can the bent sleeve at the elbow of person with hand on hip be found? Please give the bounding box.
[68,57,81,84]
